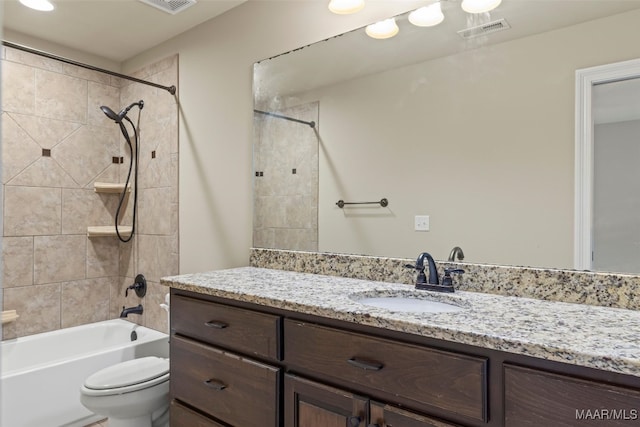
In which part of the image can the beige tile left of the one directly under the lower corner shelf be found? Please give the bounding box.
[33,235,88,284]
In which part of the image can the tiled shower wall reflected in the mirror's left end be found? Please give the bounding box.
[253,102,318,251]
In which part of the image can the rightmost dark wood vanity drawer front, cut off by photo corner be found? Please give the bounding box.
[504,365,640,427]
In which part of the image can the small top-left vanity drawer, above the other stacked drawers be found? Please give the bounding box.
[171,295,280,360]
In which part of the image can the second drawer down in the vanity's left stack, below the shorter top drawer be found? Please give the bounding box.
[170,335,280,427]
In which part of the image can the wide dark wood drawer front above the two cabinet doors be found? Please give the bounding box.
[285,319,487,421]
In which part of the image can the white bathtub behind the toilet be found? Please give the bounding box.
[0,319,169,427]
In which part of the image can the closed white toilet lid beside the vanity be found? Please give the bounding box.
[84,356,169,390]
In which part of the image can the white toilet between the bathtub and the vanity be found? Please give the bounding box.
[80,356,169,427]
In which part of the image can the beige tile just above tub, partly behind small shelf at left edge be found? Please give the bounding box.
[3,283,60,338]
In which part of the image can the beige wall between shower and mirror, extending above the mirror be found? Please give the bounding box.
[123,1,418,273]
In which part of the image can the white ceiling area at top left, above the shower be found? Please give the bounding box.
[0,0,246,63]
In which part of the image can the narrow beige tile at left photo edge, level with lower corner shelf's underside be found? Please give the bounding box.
[2,237,33,288]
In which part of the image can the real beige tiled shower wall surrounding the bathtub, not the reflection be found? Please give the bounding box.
[1,47,179,339]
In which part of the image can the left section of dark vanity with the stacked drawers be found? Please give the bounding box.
[170,294,282,427]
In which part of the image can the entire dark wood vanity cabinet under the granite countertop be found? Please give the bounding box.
[170,289,640,427]
